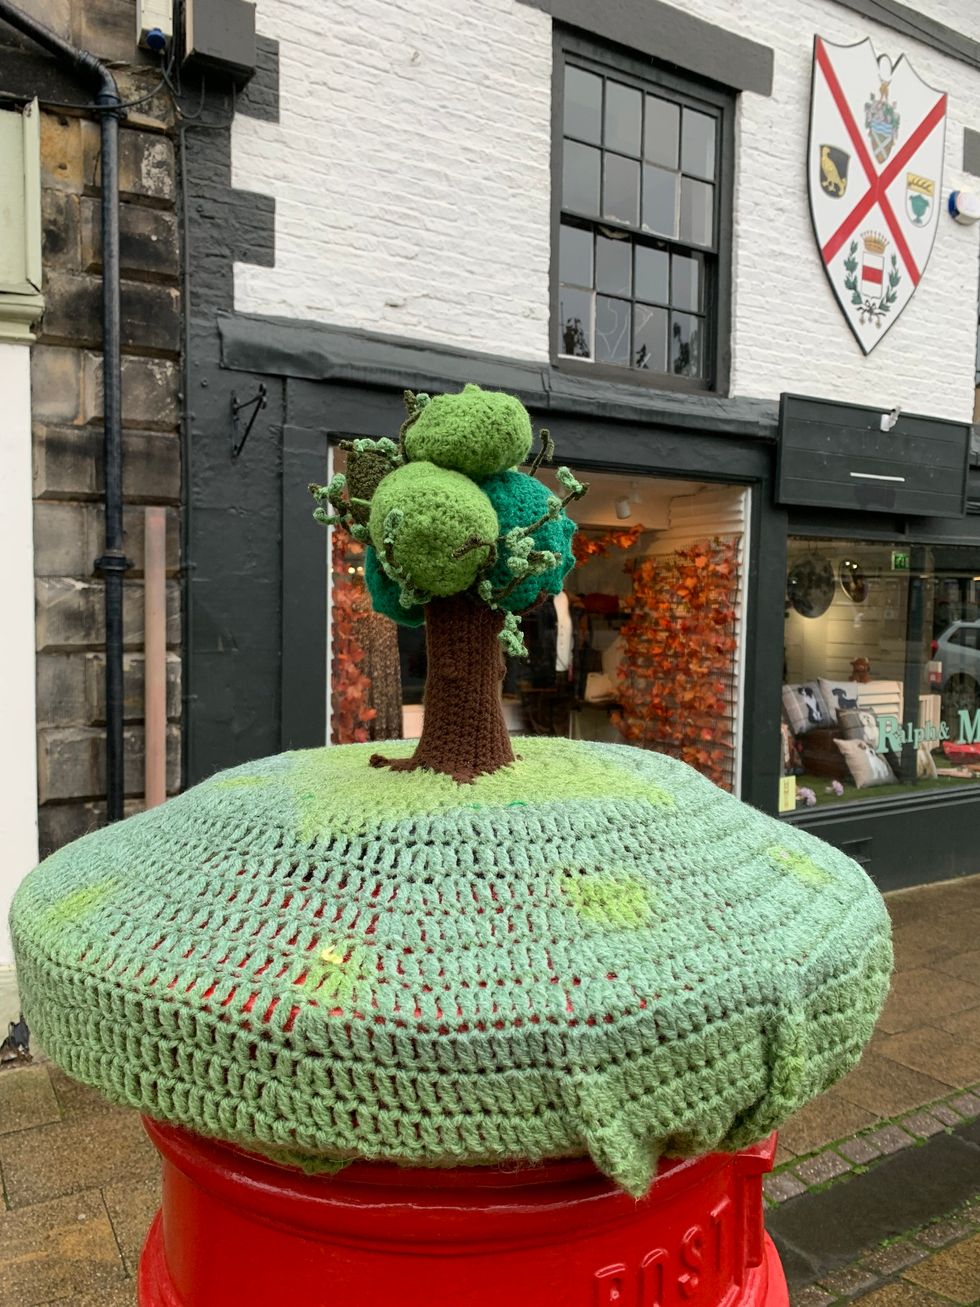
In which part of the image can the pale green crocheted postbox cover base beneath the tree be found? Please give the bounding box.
[12,738,891,1195]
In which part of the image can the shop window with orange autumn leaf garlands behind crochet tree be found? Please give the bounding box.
[329,451,747,791]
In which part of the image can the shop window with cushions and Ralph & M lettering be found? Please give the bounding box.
[780,537,980,812]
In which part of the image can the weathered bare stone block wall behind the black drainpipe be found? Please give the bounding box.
[0,0,182,855]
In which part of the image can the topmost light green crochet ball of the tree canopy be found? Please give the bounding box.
[404,384,532,481]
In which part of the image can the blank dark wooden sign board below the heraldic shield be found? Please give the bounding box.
[776,395,971,518]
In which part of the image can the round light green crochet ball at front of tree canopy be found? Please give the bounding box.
[368,462,498,597]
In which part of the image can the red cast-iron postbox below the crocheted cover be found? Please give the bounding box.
[140,1120,788,1307]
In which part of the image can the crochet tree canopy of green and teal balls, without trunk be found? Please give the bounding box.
[310,384,587,654]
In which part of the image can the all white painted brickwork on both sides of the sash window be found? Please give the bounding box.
[233,0,980,420]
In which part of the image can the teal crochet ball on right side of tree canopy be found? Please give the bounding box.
[480,472,575,613]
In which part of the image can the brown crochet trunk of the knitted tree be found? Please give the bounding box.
[371,595,514,784]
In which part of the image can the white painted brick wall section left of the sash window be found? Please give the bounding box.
[233,0,551,358]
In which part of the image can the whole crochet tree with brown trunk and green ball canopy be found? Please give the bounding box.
[310,386,587,782]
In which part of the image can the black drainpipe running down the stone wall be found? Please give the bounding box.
[0,0,132,821]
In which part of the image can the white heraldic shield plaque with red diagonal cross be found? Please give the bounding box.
[806,37,946,354]
